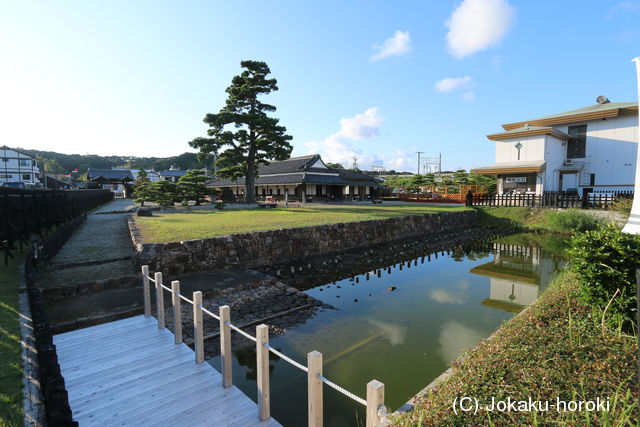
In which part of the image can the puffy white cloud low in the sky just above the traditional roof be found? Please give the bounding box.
[304,107,413,170]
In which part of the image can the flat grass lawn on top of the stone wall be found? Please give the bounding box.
[136,204,466,243]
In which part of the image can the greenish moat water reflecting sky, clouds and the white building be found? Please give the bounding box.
[209,234,563,426]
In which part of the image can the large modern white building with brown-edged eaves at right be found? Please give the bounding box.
[472,96,638,195]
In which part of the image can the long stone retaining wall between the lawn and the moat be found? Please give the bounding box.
[129,210,476,276]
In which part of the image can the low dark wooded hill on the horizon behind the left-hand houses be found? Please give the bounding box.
[11,148,211,174]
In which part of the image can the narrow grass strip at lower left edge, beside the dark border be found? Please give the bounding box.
[0,252,25,426]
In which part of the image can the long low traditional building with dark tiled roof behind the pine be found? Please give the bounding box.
[208,154,380,200]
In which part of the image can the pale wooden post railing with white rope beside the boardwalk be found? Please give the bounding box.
[142,265,387,427]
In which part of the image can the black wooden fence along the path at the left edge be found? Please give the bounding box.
[0,188,113,264]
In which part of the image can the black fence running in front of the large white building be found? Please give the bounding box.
[473,191,633,209]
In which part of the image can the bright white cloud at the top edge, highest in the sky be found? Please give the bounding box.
[446,0,515,58]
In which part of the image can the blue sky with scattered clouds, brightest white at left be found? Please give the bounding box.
[0,0,640,171]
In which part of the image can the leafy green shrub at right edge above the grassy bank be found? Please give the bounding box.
[569,224,640,326]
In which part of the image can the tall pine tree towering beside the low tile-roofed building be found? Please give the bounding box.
[189,61,293,203]
